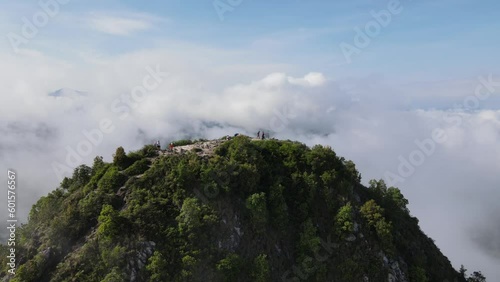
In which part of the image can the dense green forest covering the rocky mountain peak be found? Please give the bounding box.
[1,136,485,282]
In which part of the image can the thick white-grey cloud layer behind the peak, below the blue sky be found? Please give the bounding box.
[0,50,500,278]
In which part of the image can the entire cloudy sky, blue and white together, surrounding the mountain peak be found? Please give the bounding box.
[0,0,500,278]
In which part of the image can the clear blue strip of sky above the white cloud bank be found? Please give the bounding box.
[2,0,500,79]
